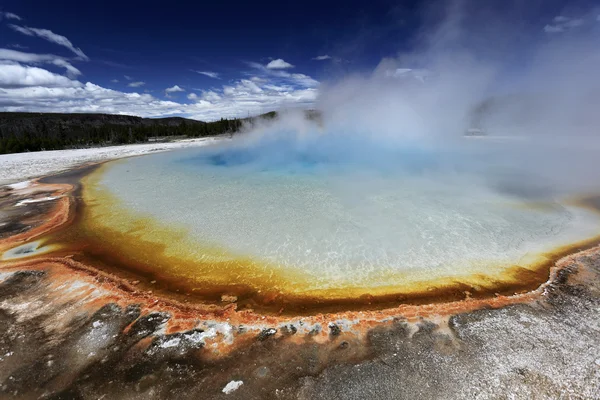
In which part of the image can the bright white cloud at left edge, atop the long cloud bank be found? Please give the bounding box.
[0,64,81,90]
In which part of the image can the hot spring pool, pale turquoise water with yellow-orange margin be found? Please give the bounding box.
[71,138,599,310]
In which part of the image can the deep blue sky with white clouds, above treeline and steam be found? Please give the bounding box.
[0,0,597,120]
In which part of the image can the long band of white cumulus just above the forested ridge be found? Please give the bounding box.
[0,75,317,121]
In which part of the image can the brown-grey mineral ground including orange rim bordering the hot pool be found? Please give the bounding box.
[0,173,600,399]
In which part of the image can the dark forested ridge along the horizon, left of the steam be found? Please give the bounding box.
[0,112,277,154]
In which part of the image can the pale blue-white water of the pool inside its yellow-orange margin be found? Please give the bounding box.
[89,135,600,287]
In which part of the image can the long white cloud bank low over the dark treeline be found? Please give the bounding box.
[0,60,318,121]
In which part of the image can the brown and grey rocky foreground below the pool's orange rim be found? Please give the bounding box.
[0,241,600,399]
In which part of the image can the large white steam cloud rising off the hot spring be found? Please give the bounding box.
[197,1,600,199]
